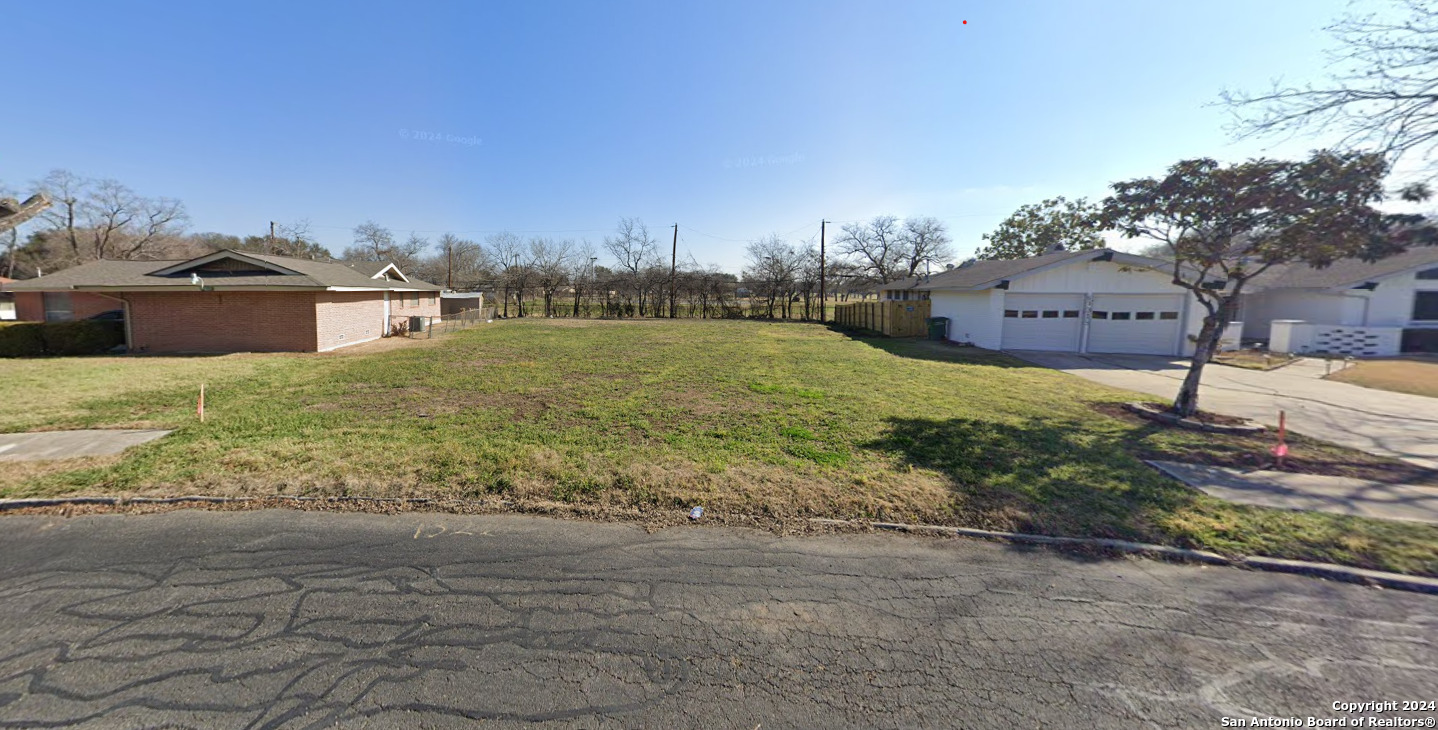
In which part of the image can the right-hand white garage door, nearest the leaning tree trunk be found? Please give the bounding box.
[1089,295,1183,355]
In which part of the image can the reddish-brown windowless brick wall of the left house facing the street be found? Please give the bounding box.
[122,292,316,352]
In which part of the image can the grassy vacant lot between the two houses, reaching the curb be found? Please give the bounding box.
[8,320,1438,575]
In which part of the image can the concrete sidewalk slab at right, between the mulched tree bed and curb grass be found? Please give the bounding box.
[1149,461,1438,525]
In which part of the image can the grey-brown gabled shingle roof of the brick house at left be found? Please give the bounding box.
[6,249,440,292]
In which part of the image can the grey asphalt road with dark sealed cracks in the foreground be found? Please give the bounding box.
[0,510,1438,730]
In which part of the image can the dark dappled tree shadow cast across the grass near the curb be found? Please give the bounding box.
[861,418,1195,557]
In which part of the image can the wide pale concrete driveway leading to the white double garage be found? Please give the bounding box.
[1009,351,1438,468]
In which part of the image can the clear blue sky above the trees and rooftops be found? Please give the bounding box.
[0,0,1347,269]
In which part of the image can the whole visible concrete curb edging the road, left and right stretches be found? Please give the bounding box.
[0,494,1438,595]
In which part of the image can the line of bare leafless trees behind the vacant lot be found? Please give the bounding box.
[0,170,953,319]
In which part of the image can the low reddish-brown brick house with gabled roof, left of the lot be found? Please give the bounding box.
[4,250,440,352]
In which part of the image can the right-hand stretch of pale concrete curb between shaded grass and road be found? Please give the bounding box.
[810,517,1438,595]
